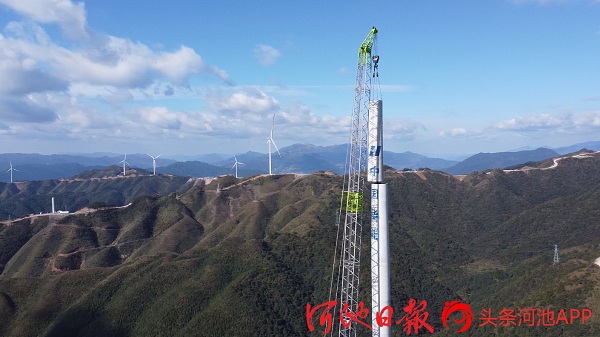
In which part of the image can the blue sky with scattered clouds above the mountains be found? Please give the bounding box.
[0,0,600,158]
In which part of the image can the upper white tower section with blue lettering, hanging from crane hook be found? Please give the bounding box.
[367,100,383,183]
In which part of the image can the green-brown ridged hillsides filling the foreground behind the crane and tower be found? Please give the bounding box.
[0,154,600,337]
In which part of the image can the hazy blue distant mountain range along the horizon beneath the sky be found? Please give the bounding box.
[0,142,600,182]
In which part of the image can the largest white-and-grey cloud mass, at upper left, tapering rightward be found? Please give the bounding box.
[0,0,230,133]
